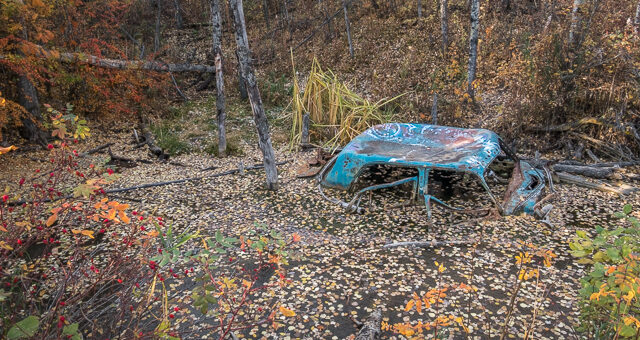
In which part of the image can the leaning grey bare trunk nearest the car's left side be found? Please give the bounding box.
[229,0,278,190]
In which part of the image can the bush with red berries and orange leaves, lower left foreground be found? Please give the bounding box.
[0,107,299,339]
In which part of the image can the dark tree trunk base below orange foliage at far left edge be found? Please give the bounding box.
[18,75,47,146]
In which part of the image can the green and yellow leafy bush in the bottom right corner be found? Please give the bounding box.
[569,204,640,339]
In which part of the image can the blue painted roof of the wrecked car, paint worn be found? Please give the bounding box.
[323,123,500,189]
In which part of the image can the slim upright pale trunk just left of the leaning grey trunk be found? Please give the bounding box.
[210,0,227,157]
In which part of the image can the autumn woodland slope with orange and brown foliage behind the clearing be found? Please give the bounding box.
[0,0,640,150]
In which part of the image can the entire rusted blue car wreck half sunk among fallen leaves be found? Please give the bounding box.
[318,123,547,218]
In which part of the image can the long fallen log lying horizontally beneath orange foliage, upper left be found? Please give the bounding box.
[0,47,215,73]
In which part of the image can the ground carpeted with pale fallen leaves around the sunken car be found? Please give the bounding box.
[0,96,640,339]
